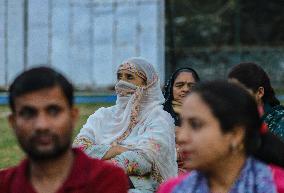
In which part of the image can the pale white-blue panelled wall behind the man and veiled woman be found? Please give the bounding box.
[0,0,165,88]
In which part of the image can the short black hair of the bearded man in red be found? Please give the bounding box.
[9,66,74,111]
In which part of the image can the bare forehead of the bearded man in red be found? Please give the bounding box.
[15,86,68,108]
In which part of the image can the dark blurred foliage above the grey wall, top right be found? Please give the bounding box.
[167,0,284,47]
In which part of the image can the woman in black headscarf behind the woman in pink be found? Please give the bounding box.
[164,67,200,175]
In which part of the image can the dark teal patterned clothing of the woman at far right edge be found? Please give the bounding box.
[262,104,284,141]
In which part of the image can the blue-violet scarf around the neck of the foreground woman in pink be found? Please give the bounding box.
[173,158,277,193]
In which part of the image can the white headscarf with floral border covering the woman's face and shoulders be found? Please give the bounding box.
[76,58,177,180]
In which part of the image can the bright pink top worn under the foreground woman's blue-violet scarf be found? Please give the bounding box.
[157,165,284,193]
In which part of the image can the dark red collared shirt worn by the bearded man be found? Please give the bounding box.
[0,149,128,193]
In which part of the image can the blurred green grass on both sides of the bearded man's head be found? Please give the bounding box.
[0,104,111,168]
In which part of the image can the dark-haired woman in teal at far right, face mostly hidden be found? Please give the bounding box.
[228,62,284,141]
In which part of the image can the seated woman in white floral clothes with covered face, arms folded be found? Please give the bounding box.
[74,58,177,193]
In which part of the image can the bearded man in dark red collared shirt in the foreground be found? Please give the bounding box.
[0,67,128,193]
